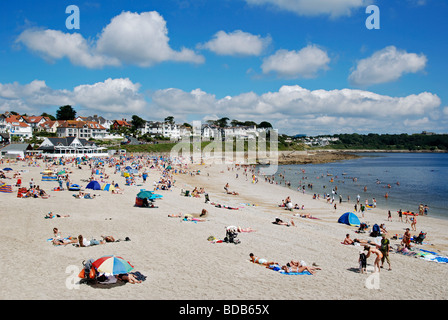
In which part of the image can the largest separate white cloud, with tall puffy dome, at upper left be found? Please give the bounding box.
[16,11,204,68]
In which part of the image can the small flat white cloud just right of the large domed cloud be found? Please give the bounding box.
[198,30,272,56]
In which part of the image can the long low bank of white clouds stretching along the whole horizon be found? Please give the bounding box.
[0,78,440,135]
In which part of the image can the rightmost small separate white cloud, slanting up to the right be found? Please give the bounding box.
[349,46,427,86]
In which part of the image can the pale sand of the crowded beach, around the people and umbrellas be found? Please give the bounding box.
[0,154,448,300]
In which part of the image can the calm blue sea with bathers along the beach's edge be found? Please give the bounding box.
[262,153,448,219]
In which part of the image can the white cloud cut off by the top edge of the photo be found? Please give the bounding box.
[246,0,372,18]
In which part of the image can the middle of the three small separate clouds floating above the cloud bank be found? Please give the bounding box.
[261,45,330,78]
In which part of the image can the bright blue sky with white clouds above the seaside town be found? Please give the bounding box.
[0,0,448,135]
